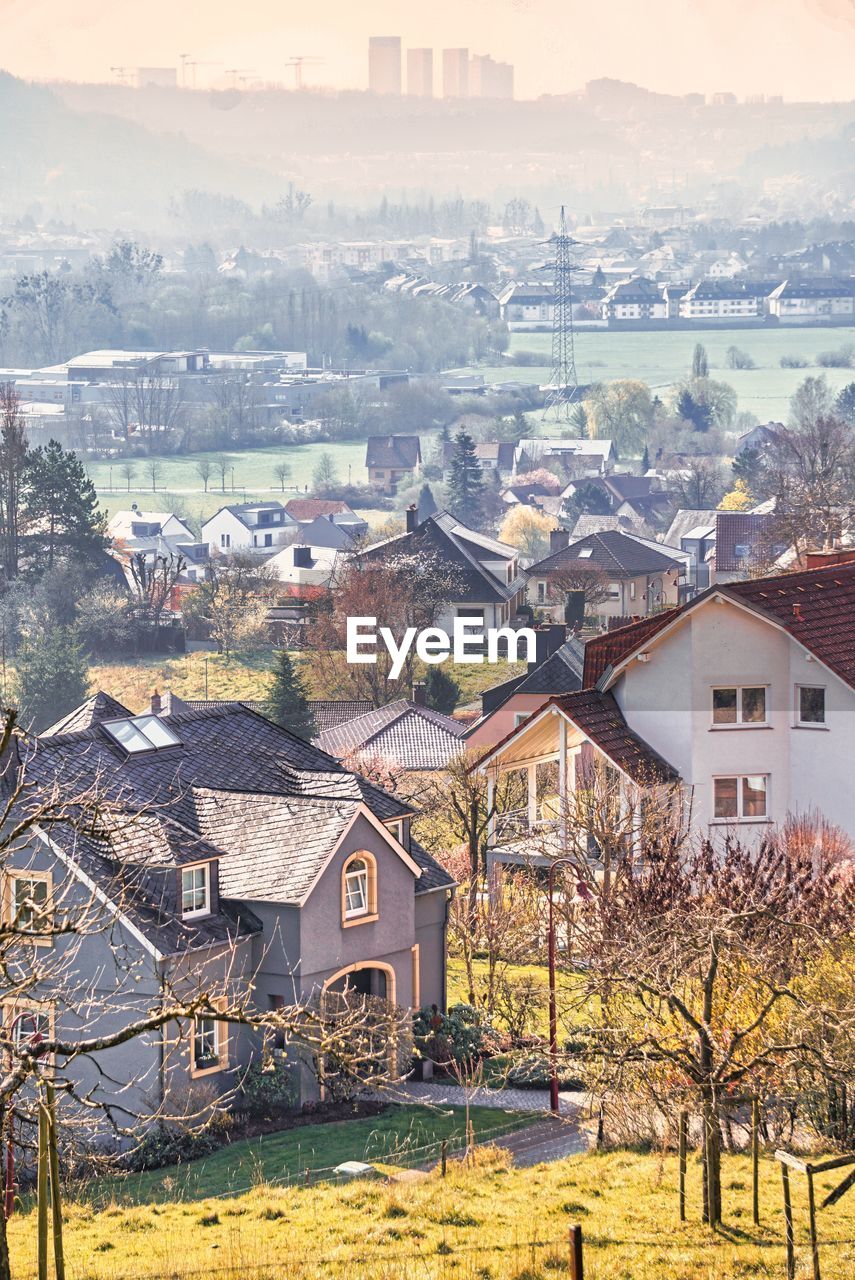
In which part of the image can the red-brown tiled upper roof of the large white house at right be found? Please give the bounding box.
[719,563,855,686]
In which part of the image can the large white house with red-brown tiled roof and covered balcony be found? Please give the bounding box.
[480,552,855,865]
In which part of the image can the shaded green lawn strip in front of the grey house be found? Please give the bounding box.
[81,1105,535,1204]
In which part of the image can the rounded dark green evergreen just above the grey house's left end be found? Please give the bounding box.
[14,627,90,733]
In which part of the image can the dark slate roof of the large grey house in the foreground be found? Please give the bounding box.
[27,696,453,954]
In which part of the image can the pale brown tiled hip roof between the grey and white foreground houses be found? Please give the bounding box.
[316,701,466,773]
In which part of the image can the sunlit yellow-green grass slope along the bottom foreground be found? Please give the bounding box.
[10,1151,855,1280]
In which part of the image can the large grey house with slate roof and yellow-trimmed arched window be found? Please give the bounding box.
[9,694,453,1116]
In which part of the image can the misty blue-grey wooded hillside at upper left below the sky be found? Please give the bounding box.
[0,72,276,230]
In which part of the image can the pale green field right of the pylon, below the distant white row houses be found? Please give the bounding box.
[477,328,855,421]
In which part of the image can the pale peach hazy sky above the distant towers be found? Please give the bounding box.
[0,0,855,100]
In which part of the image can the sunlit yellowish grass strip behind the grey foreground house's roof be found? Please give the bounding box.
[83,652,525,710]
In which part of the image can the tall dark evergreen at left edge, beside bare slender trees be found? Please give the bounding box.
[20,440,106,573]
